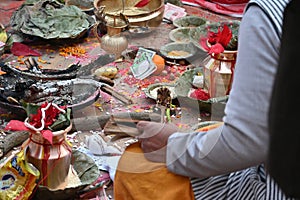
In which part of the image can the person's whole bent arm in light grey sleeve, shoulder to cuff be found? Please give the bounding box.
[167,6,280,178]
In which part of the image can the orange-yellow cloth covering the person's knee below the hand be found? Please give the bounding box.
[114,143,194,200]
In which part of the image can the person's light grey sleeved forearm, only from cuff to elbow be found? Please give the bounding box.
[167,122,267,178]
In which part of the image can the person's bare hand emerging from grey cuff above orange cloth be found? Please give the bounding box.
[137,121,178,162]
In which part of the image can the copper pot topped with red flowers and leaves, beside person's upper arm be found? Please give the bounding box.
[190,21,239,97]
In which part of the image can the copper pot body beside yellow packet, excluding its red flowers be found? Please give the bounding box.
[25,124,72,190]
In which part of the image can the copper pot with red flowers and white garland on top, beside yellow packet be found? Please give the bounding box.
[5,102,72,190]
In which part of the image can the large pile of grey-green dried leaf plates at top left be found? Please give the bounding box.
[11,0,95,39]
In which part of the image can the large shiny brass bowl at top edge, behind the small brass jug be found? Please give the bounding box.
[94,0,165,27]
